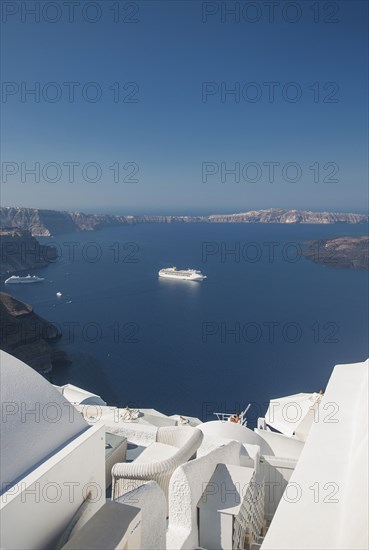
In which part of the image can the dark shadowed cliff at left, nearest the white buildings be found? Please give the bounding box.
[0,292,69,374]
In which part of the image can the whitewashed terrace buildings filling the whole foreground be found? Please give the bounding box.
[0,352,368,550]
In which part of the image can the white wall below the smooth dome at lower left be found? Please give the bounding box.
[0,426,105,550]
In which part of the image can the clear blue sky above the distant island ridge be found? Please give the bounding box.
[1,0,368,214]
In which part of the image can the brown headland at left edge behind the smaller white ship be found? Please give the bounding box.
[0,229,57,275]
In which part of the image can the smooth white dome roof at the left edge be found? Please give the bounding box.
[0,351,89,490]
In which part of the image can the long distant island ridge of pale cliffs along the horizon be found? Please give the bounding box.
[0,207,369,237]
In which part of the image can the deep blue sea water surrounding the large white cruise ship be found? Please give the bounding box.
[2,224,368,424]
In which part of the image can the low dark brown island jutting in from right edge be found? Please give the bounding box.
[303,237,369,269]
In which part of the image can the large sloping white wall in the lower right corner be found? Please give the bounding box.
[262,361,369,550]
